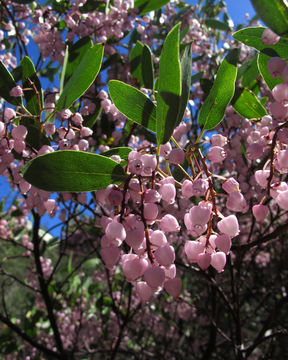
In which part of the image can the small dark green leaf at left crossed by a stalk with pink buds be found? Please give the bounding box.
[21,56,43,115]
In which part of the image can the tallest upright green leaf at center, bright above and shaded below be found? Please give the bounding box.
[156,23,181,144]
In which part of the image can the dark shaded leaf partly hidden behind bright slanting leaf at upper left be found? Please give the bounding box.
[60,36,93,88]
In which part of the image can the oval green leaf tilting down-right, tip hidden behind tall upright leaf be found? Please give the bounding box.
[108,80,156,132]
